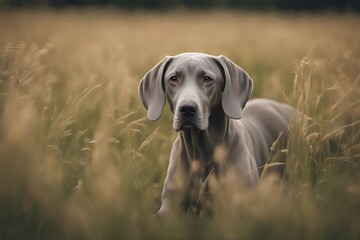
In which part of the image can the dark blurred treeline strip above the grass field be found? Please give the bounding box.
[0,0,360,11]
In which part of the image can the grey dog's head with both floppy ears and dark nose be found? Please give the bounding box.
[139,53,253,131]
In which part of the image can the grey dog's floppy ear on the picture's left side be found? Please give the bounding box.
[139,56,172,121]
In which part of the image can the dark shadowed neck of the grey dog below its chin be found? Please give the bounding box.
[180,104,229,174]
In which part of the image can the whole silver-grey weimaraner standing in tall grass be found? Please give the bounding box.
[139,53,295,214]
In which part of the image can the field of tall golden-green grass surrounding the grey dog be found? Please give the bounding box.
[0,9,360,239]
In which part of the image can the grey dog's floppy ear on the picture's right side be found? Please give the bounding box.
[216,56,253,119]
